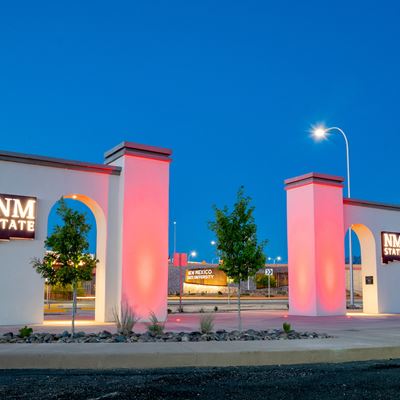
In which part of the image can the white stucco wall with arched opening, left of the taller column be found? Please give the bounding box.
[0,161,118,325]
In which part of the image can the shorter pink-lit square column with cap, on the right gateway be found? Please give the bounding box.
[285,173,346,316]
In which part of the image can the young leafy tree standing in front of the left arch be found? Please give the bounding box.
[32,198,98,336]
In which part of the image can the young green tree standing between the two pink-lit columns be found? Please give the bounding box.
[209,186,267,331]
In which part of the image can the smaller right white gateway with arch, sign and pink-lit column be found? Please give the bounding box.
[285,173,400,316]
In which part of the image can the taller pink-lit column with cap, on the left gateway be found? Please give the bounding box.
[106,142,171,320]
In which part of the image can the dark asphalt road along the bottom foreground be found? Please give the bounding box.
[0,360,400,400]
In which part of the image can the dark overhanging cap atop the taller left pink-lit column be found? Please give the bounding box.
[104,142,172,164]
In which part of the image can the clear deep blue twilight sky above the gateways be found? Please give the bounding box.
[0,0,400,260]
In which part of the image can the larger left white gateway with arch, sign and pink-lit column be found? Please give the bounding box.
[0,142,171,325]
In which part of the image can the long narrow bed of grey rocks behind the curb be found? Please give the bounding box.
[0,329,331,343]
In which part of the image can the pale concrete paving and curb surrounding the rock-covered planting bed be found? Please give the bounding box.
[0,311,400,369]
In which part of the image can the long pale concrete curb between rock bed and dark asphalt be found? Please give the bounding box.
[0,339,400,369]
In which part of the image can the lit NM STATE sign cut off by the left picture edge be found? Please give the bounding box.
[0,194,36,240]
